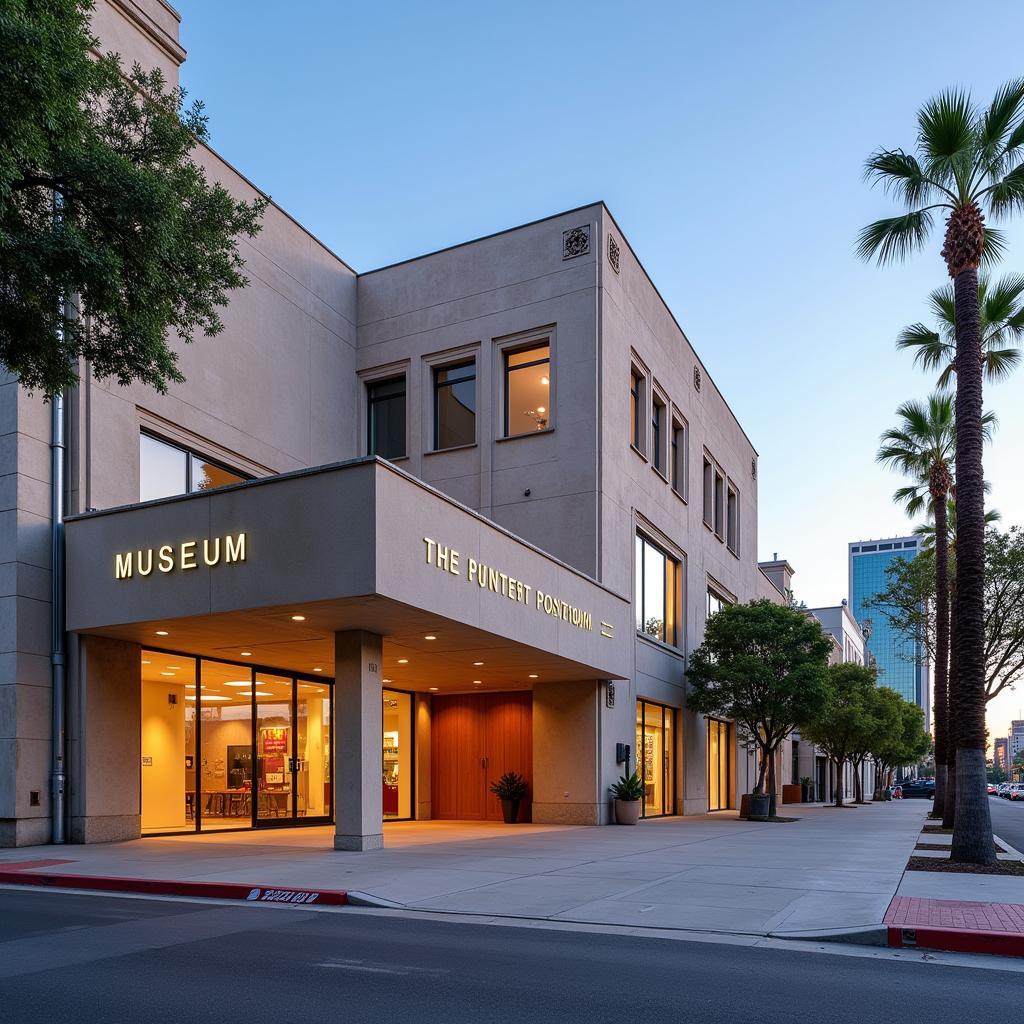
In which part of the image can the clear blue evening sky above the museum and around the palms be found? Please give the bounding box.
[176,0,1024,733]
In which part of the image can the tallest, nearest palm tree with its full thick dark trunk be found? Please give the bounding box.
[857,79,1024,864]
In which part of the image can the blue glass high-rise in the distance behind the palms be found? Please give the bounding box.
[849,537,931,728]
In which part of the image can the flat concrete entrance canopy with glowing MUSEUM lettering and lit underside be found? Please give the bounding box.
[66,459,632,691]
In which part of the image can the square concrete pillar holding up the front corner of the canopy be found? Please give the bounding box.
[334,630,384,850]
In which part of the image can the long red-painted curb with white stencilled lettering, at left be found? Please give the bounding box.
[0,869,348,906]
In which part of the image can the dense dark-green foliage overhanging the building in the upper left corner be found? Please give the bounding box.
[0,0,266,396]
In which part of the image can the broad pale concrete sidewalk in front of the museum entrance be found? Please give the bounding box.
[0,801,928,936]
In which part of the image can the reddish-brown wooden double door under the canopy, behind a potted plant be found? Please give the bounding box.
[430,690,534,821]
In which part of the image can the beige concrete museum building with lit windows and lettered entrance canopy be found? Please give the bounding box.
[0,0,780,850]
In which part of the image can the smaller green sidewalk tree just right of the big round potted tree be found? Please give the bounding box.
[800,662,878,807]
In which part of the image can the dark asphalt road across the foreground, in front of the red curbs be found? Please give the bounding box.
[0,890,1022,1024]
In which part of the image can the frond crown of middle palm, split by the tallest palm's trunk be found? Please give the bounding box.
[896,273,1024,390]
